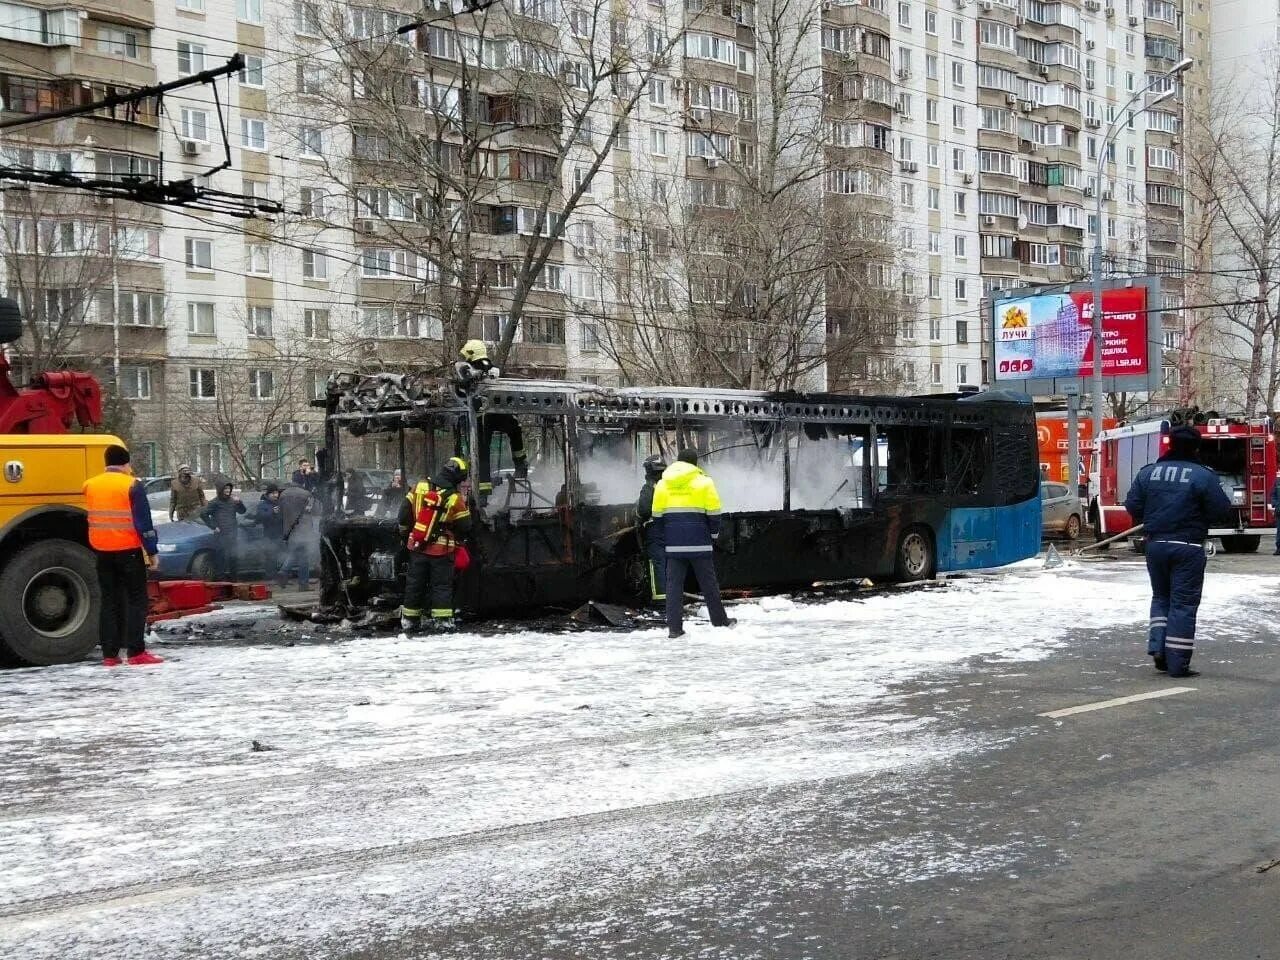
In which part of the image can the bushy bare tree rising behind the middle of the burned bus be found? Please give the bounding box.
[575,0,905,389]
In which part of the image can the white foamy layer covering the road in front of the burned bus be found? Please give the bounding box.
[0,563,1274,960]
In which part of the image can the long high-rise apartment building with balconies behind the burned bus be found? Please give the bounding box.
[0,0,1208,477]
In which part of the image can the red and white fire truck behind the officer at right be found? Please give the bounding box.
[1089,411,1276,553]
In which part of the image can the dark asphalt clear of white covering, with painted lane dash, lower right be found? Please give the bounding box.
[355,552,1280,960]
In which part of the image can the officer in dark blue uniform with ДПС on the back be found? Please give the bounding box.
[1124,426,1231,677]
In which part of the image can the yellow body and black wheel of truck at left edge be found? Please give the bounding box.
[0,434,123,666]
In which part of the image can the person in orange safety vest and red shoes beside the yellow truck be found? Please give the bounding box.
[83,444,164,667]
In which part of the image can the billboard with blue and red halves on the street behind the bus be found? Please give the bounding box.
[991,283,1160,394]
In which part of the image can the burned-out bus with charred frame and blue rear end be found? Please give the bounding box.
[321,374,1041,614]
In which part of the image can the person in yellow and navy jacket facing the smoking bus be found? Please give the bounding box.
[653,448,733,640]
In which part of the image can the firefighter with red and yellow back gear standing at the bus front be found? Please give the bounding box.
[399,457,471,634]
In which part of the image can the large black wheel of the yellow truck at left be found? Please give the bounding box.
[0,539,101,667]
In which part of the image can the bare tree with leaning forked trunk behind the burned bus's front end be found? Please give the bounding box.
[289,0,684,365]
